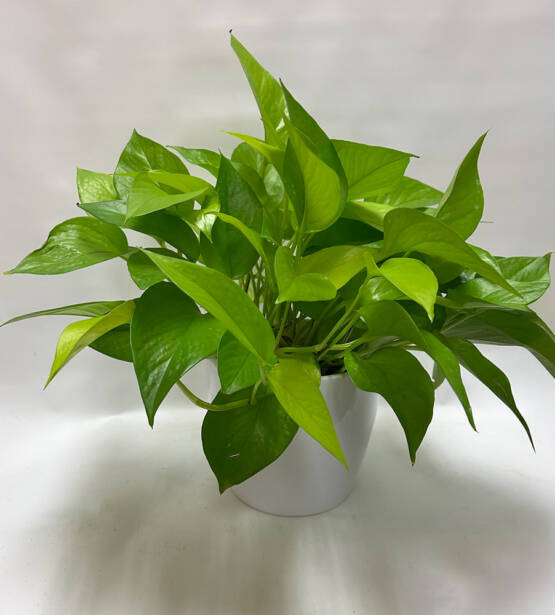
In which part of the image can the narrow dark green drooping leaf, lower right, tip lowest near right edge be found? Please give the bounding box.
[444,337,534,448]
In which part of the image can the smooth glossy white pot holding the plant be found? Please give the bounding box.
[232,374,377,517]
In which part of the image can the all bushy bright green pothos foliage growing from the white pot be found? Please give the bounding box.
[2,36,555,491]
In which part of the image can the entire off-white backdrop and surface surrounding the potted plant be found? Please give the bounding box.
[0,0,555,615]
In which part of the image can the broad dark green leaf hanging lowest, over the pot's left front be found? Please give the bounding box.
[202,394,298,493]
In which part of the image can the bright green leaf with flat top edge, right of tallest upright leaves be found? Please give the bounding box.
[332,139,413,199]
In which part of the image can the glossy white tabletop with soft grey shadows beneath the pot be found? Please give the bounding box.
[0,348,555,615]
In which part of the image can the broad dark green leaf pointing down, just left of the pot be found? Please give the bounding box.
[131,282,225,426]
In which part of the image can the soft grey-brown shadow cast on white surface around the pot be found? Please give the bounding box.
[26,410,549,615]
